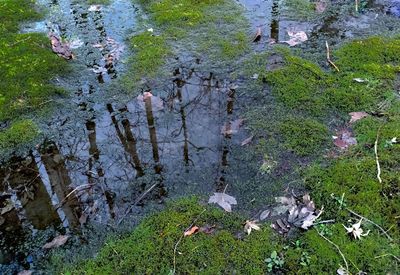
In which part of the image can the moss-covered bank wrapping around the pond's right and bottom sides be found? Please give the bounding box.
[64,37,400,274]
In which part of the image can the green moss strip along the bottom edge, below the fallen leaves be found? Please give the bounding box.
[64,199,399,274]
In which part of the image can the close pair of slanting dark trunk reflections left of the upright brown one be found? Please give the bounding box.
[107,104,144,177]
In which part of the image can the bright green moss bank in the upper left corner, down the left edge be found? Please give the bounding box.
[0,0,65,153]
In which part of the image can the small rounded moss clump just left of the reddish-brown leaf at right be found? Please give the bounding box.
[279,118,328,156]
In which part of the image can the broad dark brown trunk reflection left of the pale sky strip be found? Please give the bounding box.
[8,154,61,229]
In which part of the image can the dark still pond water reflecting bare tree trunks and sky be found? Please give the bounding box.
[0,0,399,273]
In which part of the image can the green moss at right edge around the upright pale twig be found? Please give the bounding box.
[306,102,400,235]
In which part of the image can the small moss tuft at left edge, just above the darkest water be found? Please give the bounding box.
[0,120,39,151]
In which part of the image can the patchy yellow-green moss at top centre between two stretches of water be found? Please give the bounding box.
[127,0,250,83]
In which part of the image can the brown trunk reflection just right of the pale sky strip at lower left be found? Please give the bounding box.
[41,143,82,227]
